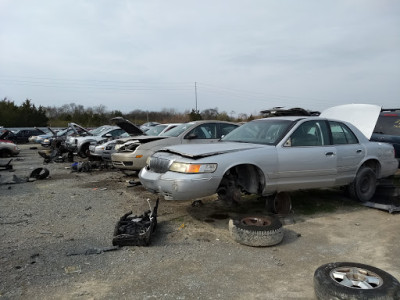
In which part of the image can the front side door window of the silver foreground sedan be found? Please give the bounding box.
[284,120,329,147]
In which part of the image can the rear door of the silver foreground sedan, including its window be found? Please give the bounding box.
[329,121,365,185]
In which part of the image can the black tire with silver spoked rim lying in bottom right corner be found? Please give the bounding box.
[314,262,400,300]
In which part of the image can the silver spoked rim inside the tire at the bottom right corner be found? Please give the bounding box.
[330,266,383,290]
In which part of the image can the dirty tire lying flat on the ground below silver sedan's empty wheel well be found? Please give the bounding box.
[229,216,283,247]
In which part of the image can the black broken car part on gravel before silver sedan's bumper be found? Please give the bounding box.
[112,198,159,246]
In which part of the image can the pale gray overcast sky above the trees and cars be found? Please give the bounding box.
[0,0,400,115]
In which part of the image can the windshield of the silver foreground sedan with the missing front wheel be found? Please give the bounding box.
[222,118,293,145]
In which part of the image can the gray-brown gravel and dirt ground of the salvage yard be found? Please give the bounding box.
[0,145,400,299]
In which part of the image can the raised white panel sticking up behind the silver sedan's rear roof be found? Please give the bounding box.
[320,104,382,139]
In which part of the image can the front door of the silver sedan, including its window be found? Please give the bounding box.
[277,120,336,190]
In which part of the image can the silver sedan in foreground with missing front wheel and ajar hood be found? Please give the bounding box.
[139,107,397,202]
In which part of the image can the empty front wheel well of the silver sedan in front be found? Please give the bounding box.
[220,164,265,194]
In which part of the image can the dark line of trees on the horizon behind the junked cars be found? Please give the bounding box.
[0,98,258,127]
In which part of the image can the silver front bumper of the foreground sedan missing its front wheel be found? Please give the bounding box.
[139,168,222,200]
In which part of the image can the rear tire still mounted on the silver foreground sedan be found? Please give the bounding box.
[349,167,376,202]
